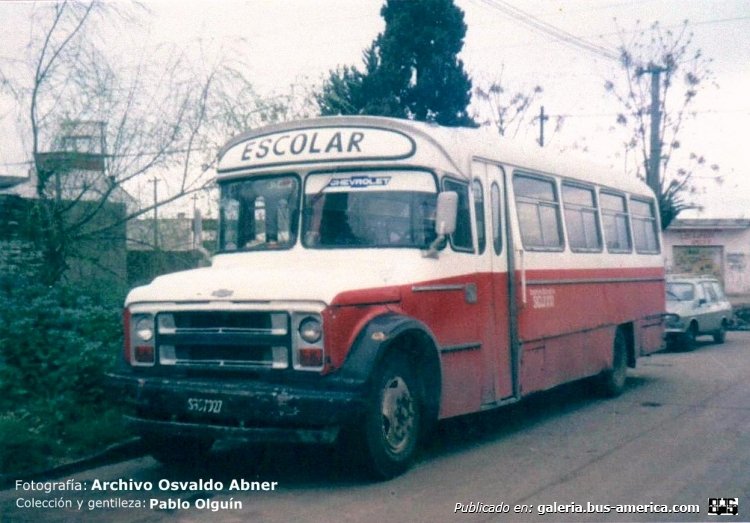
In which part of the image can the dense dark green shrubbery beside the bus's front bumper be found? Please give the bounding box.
[0,248,125,473]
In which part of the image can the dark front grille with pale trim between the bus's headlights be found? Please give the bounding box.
[156,311,291,369]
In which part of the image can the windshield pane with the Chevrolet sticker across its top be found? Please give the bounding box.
[302,171,437,249]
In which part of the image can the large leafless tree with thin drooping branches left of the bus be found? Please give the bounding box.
[0,0,304,283]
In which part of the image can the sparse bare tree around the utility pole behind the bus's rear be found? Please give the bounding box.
[605,20,722,228]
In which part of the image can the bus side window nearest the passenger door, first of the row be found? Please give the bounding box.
[513,174,563,251]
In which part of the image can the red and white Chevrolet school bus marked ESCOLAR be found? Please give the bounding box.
[110,117,664,477]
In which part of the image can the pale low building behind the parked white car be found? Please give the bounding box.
[664,219,750,295]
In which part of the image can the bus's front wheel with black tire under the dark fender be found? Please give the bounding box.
[360,354,422,479]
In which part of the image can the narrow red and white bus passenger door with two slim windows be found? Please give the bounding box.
[472,161,515,405]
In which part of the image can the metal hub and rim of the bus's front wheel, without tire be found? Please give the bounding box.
[381,376,415,453]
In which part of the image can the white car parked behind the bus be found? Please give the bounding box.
[665,275,732,350]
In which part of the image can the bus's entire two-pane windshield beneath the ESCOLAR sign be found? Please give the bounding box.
[219,171,437,252]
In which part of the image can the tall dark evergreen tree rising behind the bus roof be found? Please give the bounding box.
[316,0,476,126]
